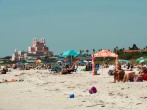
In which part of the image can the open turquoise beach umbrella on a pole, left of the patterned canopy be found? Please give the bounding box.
[62,50,81,62]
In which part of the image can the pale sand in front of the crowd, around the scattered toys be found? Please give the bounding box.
[0,66,147,110]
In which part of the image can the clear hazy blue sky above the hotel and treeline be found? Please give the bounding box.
[0,0,147,57]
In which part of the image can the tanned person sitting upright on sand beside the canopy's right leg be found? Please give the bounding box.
[112,67,125,82]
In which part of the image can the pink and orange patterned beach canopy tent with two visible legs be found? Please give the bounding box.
[92,50,118,75]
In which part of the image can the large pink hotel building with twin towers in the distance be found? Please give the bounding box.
[12,38,53,61]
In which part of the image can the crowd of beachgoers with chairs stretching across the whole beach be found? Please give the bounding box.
[0,60,147,82]
